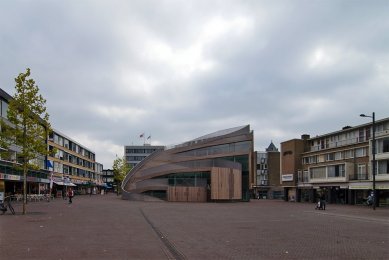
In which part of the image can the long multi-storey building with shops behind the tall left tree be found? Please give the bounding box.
[0,89,104,196]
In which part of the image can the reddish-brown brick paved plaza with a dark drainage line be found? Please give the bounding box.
[0,194,389,259]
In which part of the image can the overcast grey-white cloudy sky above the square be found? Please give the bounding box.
[0,0,389,168]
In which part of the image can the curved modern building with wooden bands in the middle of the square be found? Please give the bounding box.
[122,125,254,202]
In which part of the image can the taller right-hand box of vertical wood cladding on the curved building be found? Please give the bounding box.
[211,167,242,200]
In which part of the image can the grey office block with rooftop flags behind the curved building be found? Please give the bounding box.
[124,144,165,167]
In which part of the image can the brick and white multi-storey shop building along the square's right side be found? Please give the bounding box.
[282,118,389,206]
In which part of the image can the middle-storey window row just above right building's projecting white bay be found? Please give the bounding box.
[303,147,367,164]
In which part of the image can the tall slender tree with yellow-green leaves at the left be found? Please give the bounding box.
[0,68,52,214]
